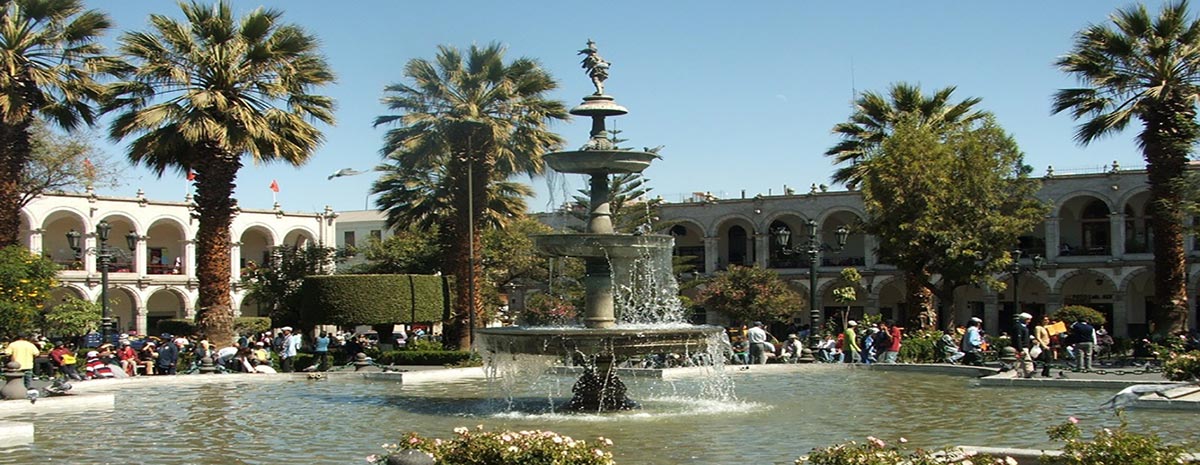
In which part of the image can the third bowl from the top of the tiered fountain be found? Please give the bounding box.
[530,233,673,259]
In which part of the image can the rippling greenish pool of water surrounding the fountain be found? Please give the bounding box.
[0,366,1200,465]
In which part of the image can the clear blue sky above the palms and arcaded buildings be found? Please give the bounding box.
[79,0,1166,211]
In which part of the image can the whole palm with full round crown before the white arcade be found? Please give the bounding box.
[108,1,334,343]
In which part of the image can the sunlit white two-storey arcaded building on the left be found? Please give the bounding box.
[20,186,337,334]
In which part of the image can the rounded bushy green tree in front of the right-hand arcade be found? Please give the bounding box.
[863,116,1046,322]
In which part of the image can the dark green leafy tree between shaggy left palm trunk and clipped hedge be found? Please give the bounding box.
[242,244,337,326]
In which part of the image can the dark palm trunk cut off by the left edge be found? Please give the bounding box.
[0,121,32,248]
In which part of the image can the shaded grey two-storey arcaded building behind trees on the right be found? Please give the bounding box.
[660,169,1200,337]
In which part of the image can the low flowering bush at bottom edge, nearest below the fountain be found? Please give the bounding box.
[367,425,614,465]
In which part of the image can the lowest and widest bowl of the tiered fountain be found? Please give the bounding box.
[475,324,725,358]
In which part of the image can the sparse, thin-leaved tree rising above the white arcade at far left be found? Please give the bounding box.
[20,120,121,206]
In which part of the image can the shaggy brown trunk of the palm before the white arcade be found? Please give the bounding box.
[194,149,241,346]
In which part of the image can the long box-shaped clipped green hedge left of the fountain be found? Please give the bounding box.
[300,274,450,326]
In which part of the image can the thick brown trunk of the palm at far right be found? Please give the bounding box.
[1139,98,1200,336]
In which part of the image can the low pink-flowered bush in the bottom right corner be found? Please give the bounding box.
[1046,411,1187,465]
